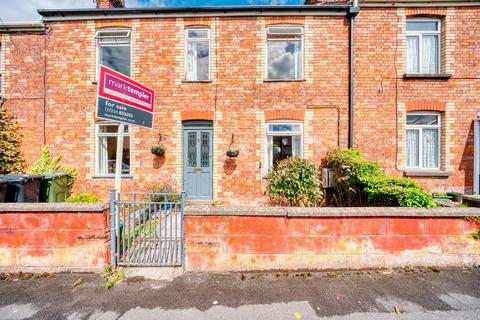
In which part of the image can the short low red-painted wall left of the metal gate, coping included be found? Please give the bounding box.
[0,204,110,270]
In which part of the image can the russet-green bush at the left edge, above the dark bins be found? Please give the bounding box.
[0,105,25,175]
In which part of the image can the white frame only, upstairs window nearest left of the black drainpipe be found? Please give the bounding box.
[264,24,305,81]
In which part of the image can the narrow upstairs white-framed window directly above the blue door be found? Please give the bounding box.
[185,28,210,81]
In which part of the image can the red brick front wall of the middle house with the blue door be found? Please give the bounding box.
[33,17,348,202]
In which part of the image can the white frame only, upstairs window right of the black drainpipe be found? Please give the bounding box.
[405,18,442,74]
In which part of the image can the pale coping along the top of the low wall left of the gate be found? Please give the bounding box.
[0,202,109,213]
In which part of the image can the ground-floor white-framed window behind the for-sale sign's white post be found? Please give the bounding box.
[96,122,130,176]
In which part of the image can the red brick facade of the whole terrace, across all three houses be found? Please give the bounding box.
[1,7,480,203]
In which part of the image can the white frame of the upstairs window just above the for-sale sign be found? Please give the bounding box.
[95,28,133,80]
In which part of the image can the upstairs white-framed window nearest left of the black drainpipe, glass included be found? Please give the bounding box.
[266,26,304,80]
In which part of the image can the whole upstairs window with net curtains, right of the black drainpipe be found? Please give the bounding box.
[406,18,441,74]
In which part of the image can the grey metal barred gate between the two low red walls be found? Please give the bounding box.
[110,191,185,266]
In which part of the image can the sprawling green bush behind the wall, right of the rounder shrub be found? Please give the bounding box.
[325,149,435,208]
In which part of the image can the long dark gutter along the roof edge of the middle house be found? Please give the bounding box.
[38,5,351,21]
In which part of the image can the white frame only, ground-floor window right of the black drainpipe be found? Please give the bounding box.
[405,111,442,171]
